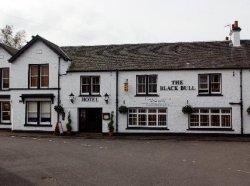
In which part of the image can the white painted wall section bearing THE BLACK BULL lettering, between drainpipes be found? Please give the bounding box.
[119,70,240,133]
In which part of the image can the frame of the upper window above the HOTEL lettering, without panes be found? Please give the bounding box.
[80,75,101,96]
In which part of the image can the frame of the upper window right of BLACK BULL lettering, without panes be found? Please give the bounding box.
[198,73,222,96]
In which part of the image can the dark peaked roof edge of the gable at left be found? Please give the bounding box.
[9,35,70,62]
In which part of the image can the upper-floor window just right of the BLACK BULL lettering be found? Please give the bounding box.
[199,74,221,94]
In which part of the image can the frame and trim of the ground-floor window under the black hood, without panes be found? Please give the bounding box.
[24,100,52,127]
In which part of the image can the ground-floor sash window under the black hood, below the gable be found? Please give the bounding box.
[26,101,51,125]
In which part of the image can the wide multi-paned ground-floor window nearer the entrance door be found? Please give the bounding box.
[128,108,167,127]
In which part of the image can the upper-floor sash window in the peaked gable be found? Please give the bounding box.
[29,65,49,88]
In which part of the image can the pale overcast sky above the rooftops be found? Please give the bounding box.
[0,0,250,45]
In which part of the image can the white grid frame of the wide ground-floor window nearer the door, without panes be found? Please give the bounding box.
[127,107,168,128]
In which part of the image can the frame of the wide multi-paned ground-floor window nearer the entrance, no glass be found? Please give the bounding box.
[127,107,168,130]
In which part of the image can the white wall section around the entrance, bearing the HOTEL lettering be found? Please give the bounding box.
[61,72,116,132]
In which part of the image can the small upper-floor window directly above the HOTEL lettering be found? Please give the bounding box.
[81,76,100,95]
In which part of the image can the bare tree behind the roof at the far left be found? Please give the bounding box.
[0,25,26,49]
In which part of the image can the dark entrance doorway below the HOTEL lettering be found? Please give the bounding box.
[79,108,102,133]
